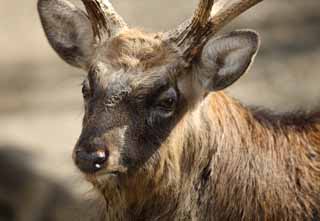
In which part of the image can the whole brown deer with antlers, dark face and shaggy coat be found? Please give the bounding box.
[38,0,320,221]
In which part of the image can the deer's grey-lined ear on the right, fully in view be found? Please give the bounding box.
[197,30,259,91]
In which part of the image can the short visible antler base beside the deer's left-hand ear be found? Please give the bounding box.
[82,0,127,41]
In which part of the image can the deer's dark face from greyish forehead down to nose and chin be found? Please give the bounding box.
[74,37,187,174]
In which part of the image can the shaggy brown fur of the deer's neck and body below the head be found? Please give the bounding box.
[87,90,320,220]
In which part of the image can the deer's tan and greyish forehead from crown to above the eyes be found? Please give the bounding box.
[89,30,188,93]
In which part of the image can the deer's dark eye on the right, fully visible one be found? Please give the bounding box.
[157,88,178,112]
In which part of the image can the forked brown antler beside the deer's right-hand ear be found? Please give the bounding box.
[168,0,263,60]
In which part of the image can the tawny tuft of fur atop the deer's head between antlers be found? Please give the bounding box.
[98,29,178,71]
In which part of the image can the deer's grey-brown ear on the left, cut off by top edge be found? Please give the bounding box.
[38,0,94,69]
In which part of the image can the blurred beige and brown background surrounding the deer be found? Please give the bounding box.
[0,0,320,221]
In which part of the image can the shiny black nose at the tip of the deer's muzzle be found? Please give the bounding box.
[75,149,108,173]
